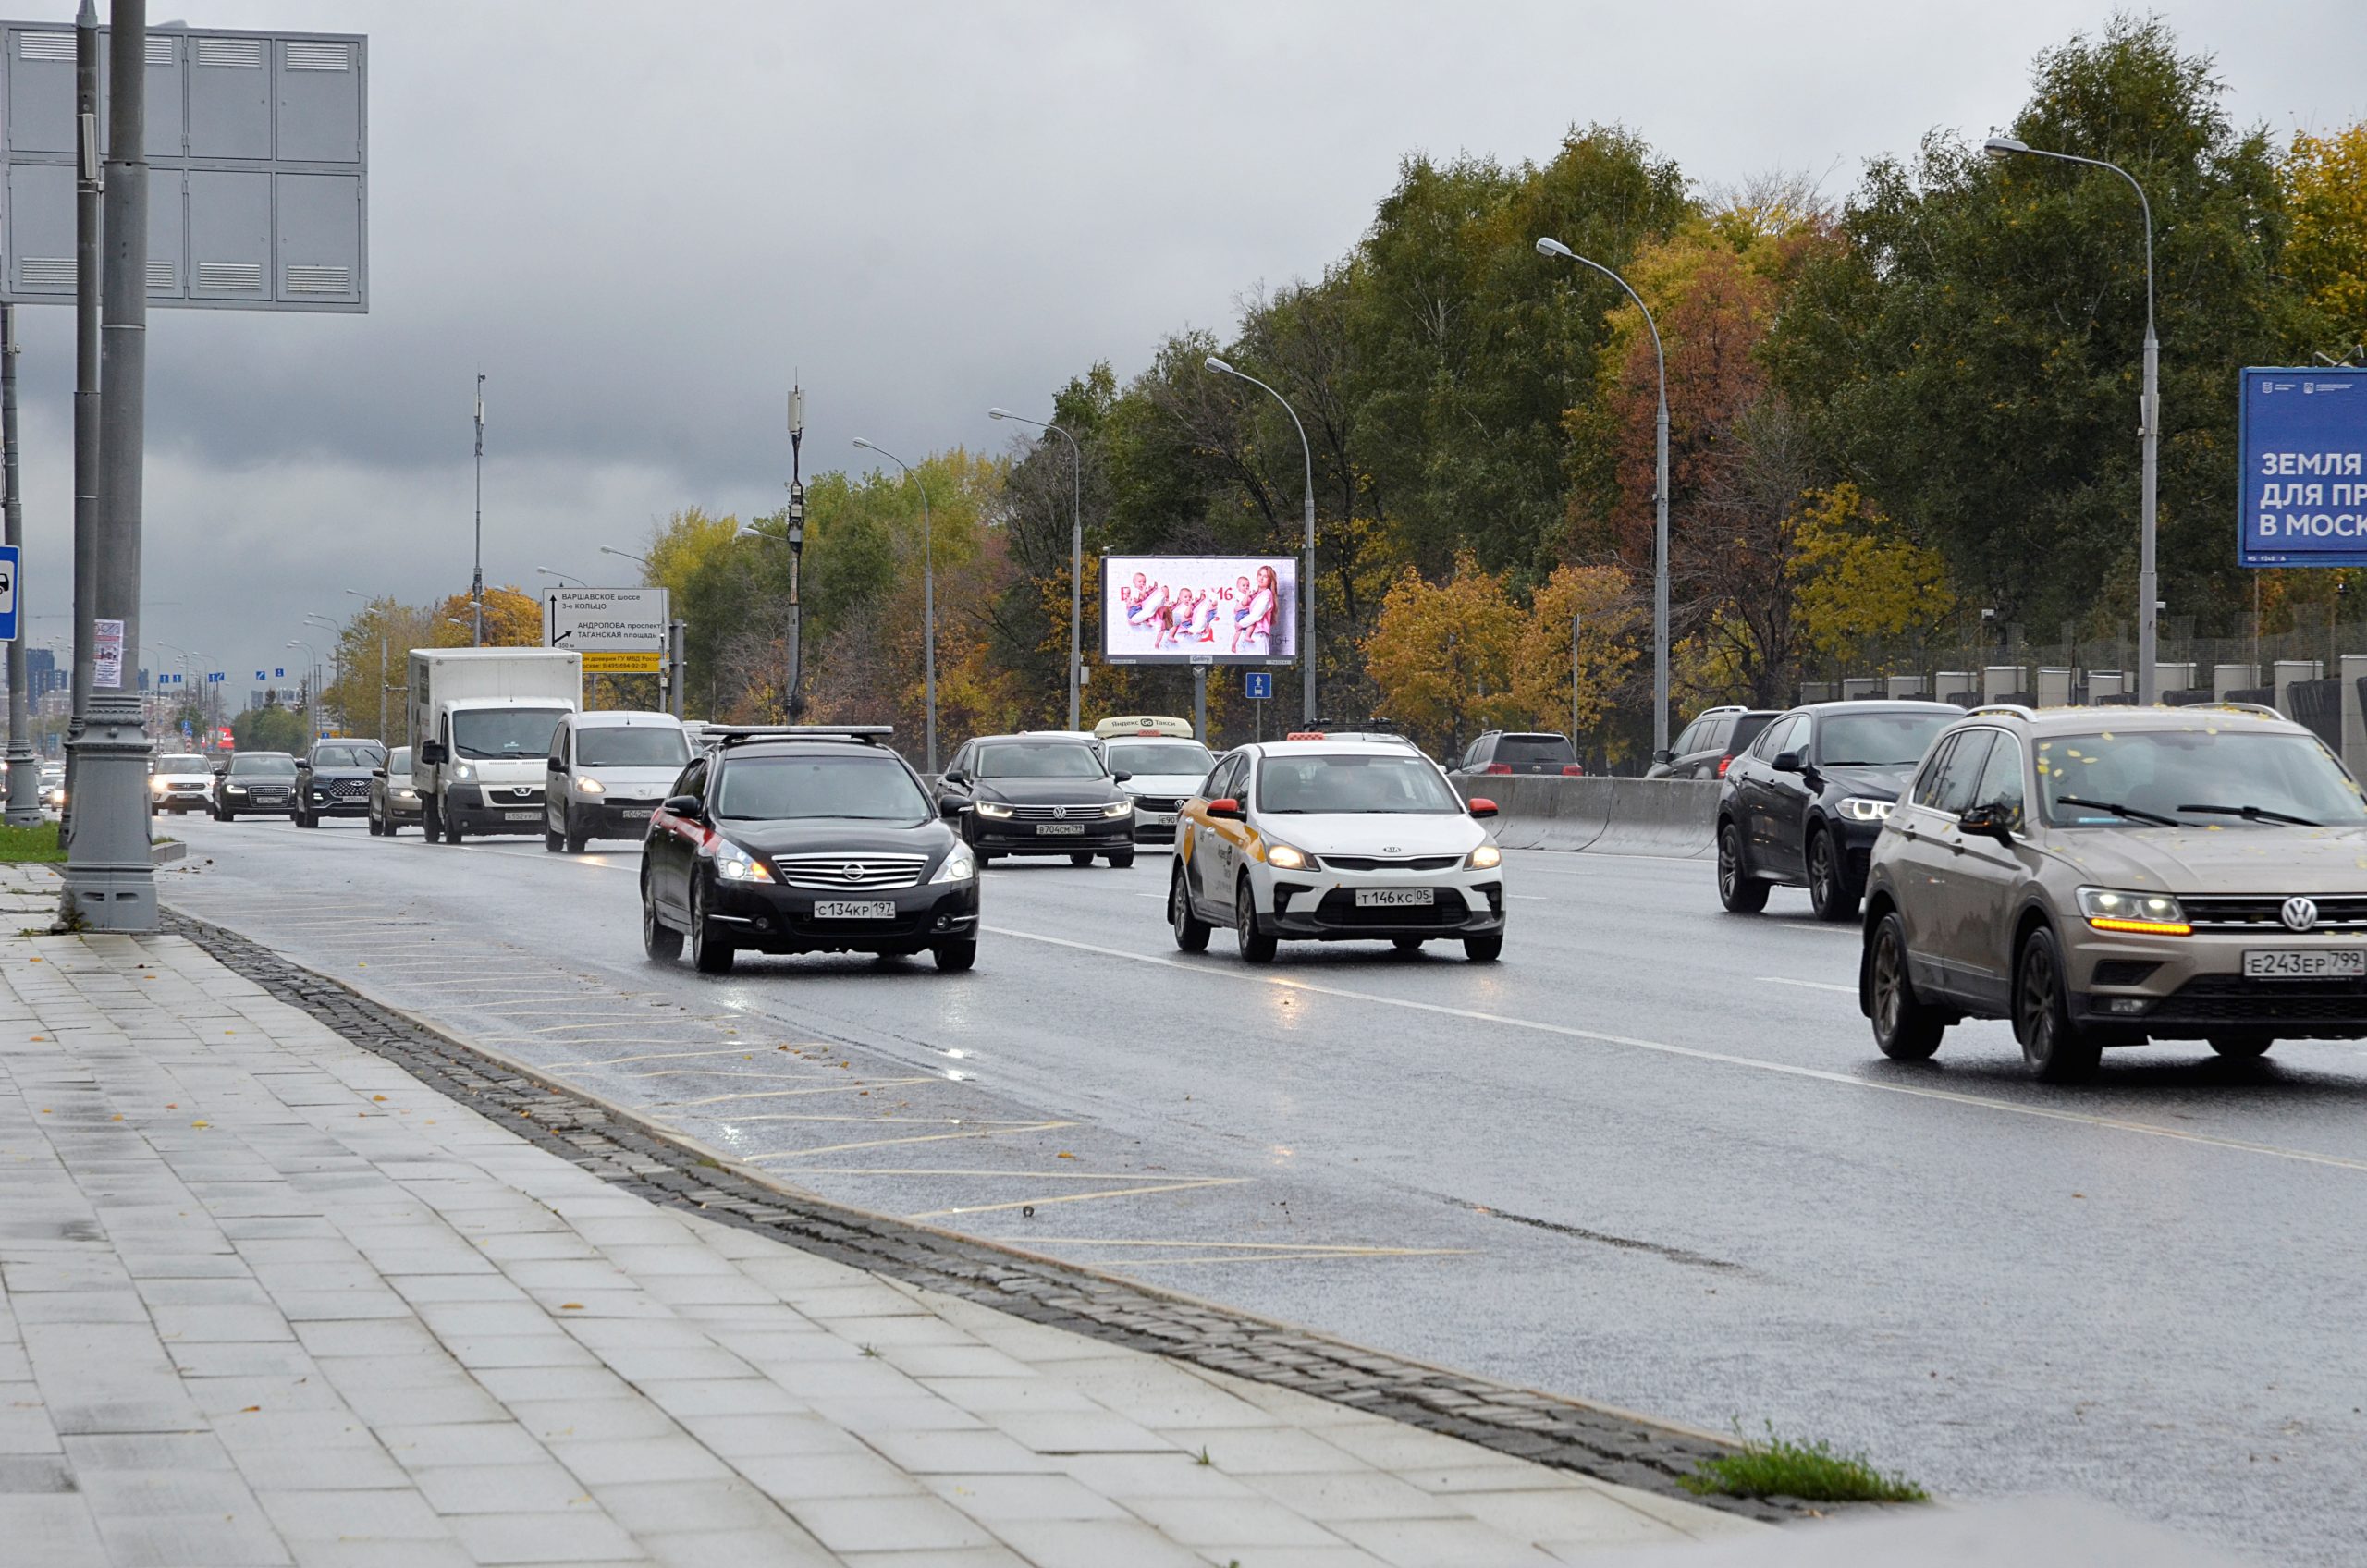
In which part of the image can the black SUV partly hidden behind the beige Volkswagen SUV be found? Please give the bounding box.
[1719,701,1965,922]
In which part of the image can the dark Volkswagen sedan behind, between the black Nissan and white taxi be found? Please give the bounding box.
[939,734,1134,869]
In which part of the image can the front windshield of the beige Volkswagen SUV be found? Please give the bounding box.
[2036,717,2367,827]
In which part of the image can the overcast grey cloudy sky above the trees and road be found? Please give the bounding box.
[9,0,2367,694]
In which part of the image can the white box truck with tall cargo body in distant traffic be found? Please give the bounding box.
[411,649,584,843]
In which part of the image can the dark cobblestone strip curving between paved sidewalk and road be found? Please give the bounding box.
[164,912,1789,1521]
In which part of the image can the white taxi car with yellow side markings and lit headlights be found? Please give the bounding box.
[1167,739,1503,964]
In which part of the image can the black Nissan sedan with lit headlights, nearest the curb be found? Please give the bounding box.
[642,725,977,974]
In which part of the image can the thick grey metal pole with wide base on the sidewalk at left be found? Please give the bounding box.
[64,0,156,931]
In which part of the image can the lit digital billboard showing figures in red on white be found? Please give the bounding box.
[1100,554,1299,663]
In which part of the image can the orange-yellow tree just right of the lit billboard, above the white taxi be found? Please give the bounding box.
[1364,552,1522,755]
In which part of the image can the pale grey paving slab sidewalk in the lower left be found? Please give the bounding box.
[0,909,1763,1568]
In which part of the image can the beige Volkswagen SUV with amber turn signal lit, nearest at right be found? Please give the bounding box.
[1858,705,2367,1080]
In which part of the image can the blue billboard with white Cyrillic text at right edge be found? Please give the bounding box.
[2237,367,2367,566]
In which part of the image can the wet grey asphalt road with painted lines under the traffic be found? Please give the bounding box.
[159,819,2367,1563]
